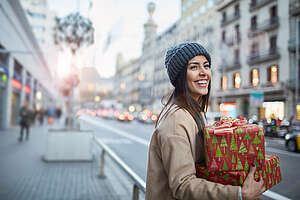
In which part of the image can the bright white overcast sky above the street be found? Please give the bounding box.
[48,0,180,77]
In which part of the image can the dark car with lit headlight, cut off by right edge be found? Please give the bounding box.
[285,126,300,151]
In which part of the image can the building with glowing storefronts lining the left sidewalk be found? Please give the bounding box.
[0,0,59,129]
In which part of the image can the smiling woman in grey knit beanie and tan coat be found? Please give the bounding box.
[146,42,265,200]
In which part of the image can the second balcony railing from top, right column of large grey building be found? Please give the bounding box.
[248,17,279,38]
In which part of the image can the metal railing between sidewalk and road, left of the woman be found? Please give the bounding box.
[93,136,146,200]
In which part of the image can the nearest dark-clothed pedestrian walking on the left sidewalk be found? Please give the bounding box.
[19,102,33,142]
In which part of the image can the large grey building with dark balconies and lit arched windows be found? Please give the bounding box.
[214,0,292,119]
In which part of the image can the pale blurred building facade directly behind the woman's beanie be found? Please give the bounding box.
[152,0,218,111]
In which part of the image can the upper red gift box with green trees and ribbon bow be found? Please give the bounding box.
[204,119,265,172]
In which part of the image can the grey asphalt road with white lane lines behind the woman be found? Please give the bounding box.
[81,115,300,199]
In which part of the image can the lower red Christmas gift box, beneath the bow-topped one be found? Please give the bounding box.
[196,155,281,189]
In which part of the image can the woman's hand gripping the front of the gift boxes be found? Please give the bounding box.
[242,164,266,200]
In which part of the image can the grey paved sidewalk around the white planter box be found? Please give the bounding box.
[0,119,132,200]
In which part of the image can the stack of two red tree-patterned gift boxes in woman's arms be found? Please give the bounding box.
[196,118,281,189]
